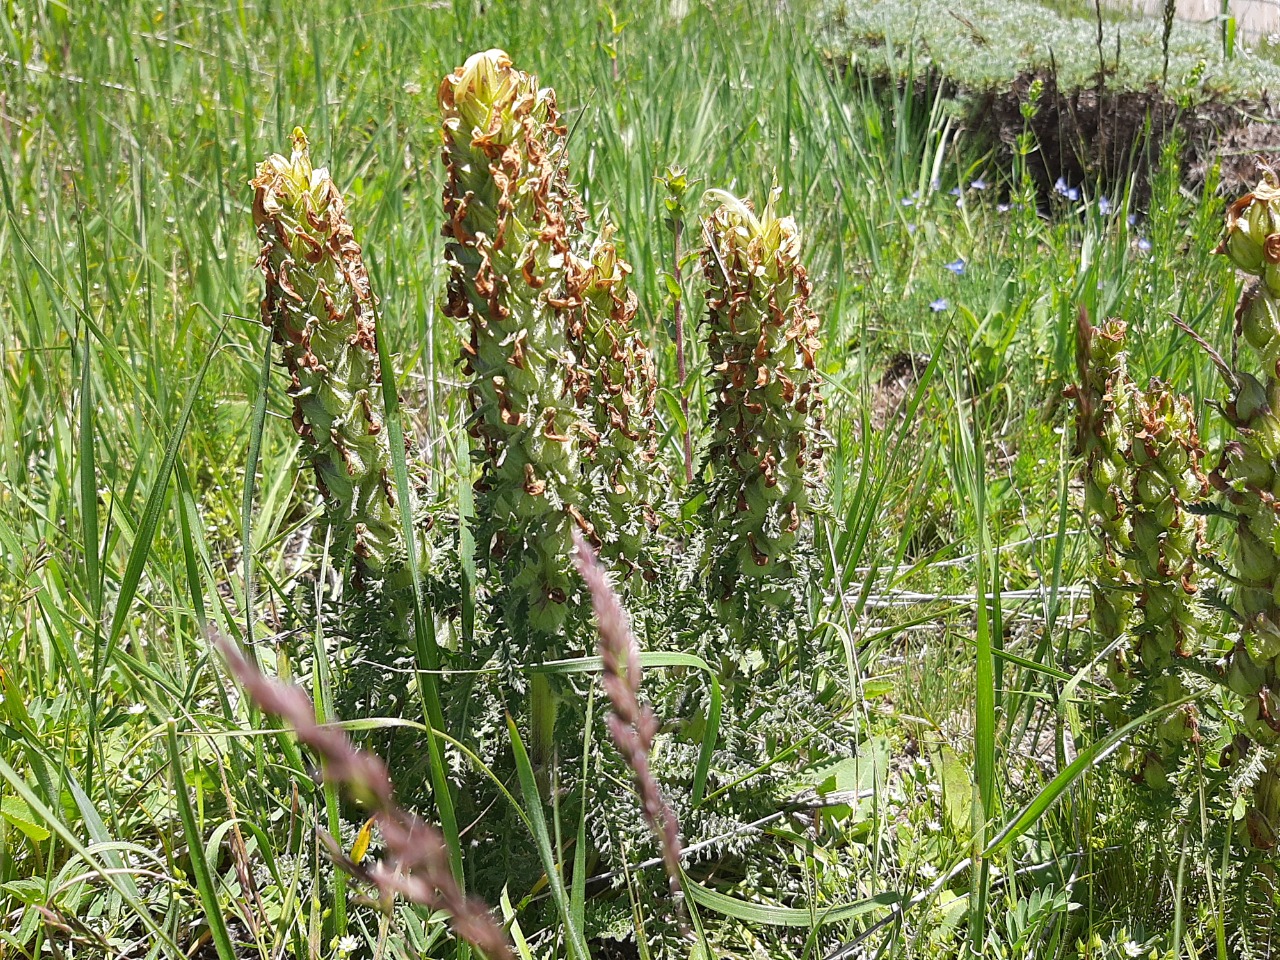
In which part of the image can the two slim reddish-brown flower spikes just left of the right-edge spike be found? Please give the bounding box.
[1070,311,1208,788]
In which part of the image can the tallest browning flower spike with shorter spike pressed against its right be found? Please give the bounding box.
[439,50,658,653]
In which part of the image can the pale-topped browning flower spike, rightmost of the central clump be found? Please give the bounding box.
[701,191,824,616]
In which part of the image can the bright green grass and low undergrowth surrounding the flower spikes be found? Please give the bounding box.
[0,0,1276,960]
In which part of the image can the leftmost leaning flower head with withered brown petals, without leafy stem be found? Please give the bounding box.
[251,129,426,579]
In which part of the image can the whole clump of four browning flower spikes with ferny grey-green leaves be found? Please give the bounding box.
[252,50,847,957]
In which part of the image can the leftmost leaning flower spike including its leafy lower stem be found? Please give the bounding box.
[251,129,448,765]
